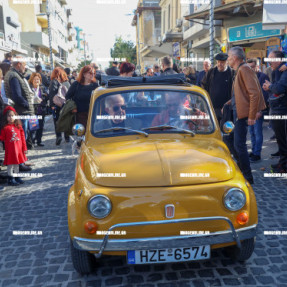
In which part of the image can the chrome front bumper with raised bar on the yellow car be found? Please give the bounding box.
[73,216,257,258]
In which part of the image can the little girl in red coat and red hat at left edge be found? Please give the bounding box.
[0,106,27,186]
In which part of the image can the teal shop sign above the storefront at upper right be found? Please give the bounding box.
[228,22,281,42]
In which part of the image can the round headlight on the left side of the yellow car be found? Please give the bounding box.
[88,195,112,218]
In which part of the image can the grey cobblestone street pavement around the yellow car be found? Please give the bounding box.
[0,118,287,287]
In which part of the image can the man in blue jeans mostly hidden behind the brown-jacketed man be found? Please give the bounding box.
[247,59,269,162]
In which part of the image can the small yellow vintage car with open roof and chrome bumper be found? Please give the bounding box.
[68,74,258,274]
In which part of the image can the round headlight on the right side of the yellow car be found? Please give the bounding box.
[223,188,246,211]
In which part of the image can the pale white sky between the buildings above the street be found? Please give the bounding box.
[67,0,138,68]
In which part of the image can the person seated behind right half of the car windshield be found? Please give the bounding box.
[152,92,209,130]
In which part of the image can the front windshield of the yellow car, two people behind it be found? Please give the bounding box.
[92,90,214,137]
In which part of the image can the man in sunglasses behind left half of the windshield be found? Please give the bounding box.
[96,94,141,130]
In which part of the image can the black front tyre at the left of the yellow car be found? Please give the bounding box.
[70,240,95,274]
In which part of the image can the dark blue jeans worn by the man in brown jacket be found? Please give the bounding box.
[234,114,253,180]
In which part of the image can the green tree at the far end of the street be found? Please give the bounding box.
[111,36,137,65]
